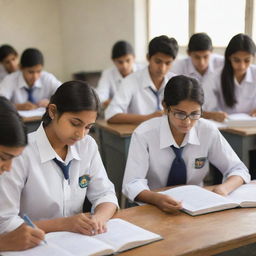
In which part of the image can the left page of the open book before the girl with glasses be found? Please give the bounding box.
[159,185,237,212]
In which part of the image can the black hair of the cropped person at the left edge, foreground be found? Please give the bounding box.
[0,96,28,147]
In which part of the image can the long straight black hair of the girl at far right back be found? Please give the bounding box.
[221,34,256,107]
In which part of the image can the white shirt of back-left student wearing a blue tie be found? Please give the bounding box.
[0,71,61,104]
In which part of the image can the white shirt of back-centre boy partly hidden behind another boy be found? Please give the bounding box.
[96,63,145,102]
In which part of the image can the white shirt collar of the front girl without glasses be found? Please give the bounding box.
[35,123,80,164]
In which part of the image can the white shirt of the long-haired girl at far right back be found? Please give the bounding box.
[203,65,256,114]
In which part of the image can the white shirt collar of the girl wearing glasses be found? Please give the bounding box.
[160,115,200,149]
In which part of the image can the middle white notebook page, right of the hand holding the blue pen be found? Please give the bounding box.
[47,232,113,256]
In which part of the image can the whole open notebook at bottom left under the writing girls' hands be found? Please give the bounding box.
[1,219,162,256]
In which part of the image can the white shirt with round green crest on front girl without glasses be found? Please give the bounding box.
[0,125,118,233]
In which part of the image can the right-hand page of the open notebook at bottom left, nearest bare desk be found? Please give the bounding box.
[95,219,161,251]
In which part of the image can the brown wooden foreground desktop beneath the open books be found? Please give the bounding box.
[114,205,256,256]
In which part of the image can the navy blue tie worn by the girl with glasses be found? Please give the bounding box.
[167,146,187,186]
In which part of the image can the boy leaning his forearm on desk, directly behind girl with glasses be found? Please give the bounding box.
[105,36,178,123]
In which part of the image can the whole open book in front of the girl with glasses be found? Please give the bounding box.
[159,183,256,216]
